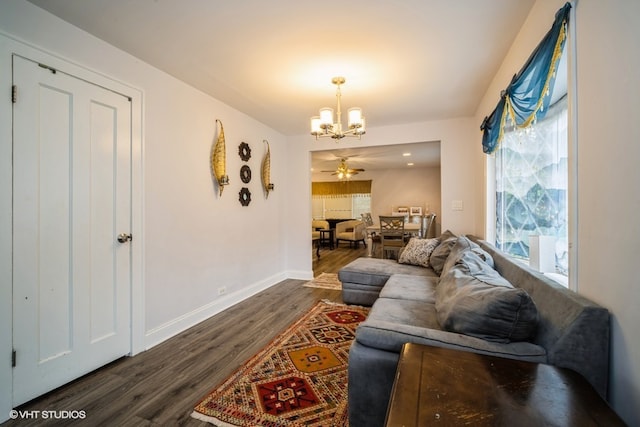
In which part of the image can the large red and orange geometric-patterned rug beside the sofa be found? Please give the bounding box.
[191,301,369,427]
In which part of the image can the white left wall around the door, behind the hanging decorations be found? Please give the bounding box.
[0,1,290,421]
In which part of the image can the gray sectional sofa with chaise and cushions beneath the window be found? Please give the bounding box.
[339,232,609,427]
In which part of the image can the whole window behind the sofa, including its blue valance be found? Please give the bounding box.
[480,2,575,284]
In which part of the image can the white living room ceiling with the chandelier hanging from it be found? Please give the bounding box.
[29,0,535,171]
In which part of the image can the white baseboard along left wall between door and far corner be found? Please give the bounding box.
[145,273,288,350]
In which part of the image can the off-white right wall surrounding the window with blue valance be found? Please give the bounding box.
[476,0,640,425]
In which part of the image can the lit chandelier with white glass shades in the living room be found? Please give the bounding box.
[311,77,365,140]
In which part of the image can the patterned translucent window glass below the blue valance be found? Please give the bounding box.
[495,96,569,275]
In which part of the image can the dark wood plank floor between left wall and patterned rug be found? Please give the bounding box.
[2,245,366,427]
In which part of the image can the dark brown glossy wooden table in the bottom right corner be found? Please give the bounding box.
[386,344,625,427]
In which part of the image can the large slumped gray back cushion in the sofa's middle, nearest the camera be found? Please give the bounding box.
[436,250,538,343]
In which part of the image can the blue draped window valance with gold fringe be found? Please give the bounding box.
[480,3,571,154]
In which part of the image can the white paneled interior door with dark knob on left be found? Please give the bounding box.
[13,56,131,405]
